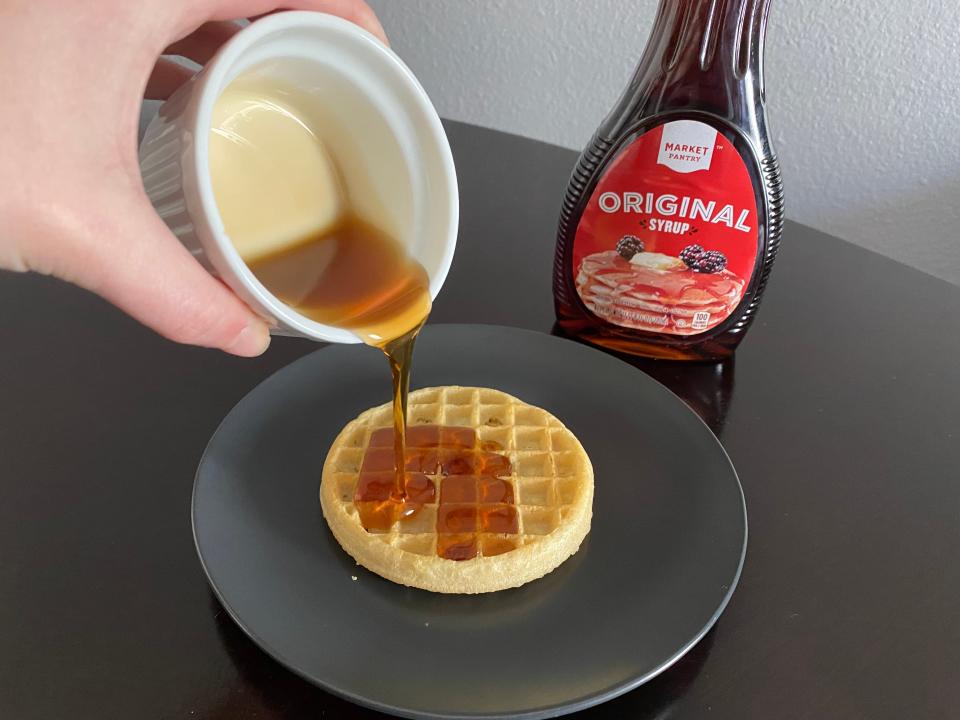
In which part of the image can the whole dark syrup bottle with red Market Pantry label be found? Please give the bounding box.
[553,0,783,360]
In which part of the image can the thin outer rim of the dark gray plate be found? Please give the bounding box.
[190,323,750,720]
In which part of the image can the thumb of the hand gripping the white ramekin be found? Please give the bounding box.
[48,194,270,357]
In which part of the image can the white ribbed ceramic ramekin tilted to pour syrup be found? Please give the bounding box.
[140,12,459,343]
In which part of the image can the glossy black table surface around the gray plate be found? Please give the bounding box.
[0,123,960,720]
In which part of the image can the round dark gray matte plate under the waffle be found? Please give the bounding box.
[193,325,747,718]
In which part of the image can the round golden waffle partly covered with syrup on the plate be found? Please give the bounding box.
[320,386,593,593]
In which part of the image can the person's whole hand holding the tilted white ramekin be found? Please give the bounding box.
[0,0,386,356]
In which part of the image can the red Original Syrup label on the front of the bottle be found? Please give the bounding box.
[573,120,759,335]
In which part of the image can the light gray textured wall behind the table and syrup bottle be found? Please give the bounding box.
[371,0,960,284]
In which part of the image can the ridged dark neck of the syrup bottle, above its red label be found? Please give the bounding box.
[604,0,770,139]
